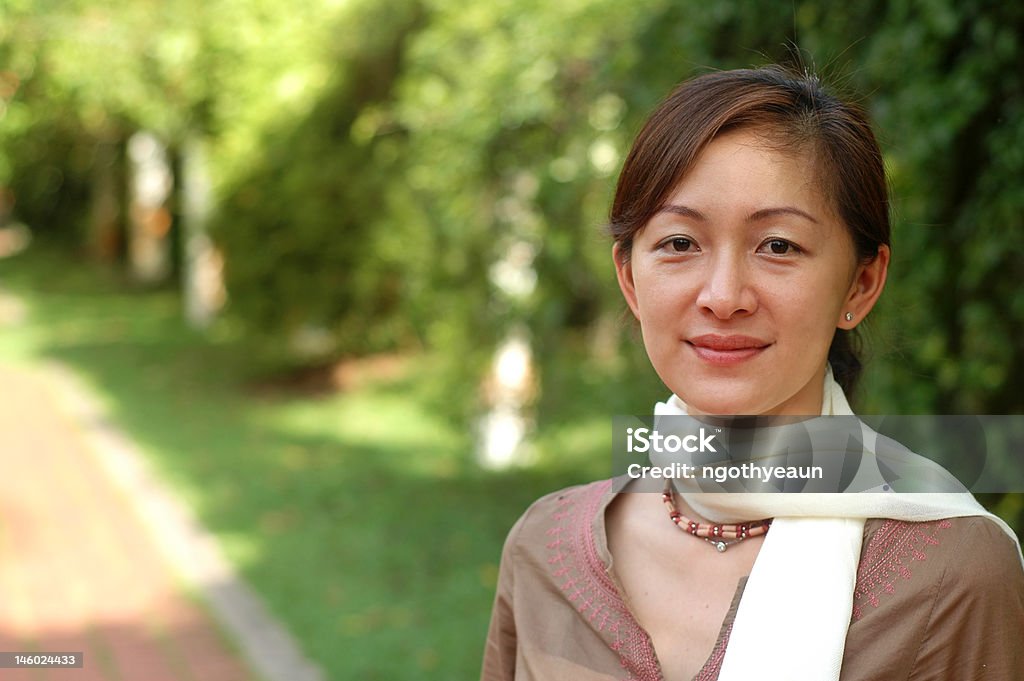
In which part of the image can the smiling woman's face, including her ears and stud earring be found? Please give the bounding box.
[614,130,889,415]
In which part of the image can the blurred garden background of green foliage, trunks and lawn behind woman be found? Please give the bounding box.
[0,0,1024,679]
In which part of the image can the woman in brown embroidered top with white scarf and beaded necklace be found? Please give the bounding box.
[482,68,1024,681]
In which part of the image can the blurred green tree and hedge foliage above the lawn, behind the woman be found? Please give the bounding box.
[0,0,1024,419]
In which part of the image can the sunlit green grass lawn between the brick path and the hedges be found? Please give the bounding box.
[0,248,610,680]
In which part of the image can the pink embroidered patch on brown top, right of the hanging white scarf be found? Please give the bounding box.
[852,520,951,622]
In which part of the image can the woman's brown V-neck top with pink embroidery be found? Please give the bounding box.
[481,480,1024,681]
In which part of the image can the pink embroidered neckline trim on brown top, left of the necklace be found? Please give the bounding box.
[547,480,663,681]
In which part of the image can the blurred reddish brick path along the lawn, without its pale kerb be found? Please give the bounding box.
[0,366,255,681]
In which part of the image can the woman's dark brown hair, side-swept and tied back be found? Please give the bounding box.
[609,66,890,393]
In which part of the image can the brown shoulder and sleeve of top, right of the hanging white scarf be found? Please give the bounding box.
[844,516,1024,681]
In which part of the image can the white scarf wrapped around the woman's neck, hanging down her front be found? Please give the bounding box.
[654,368,1024,681]
